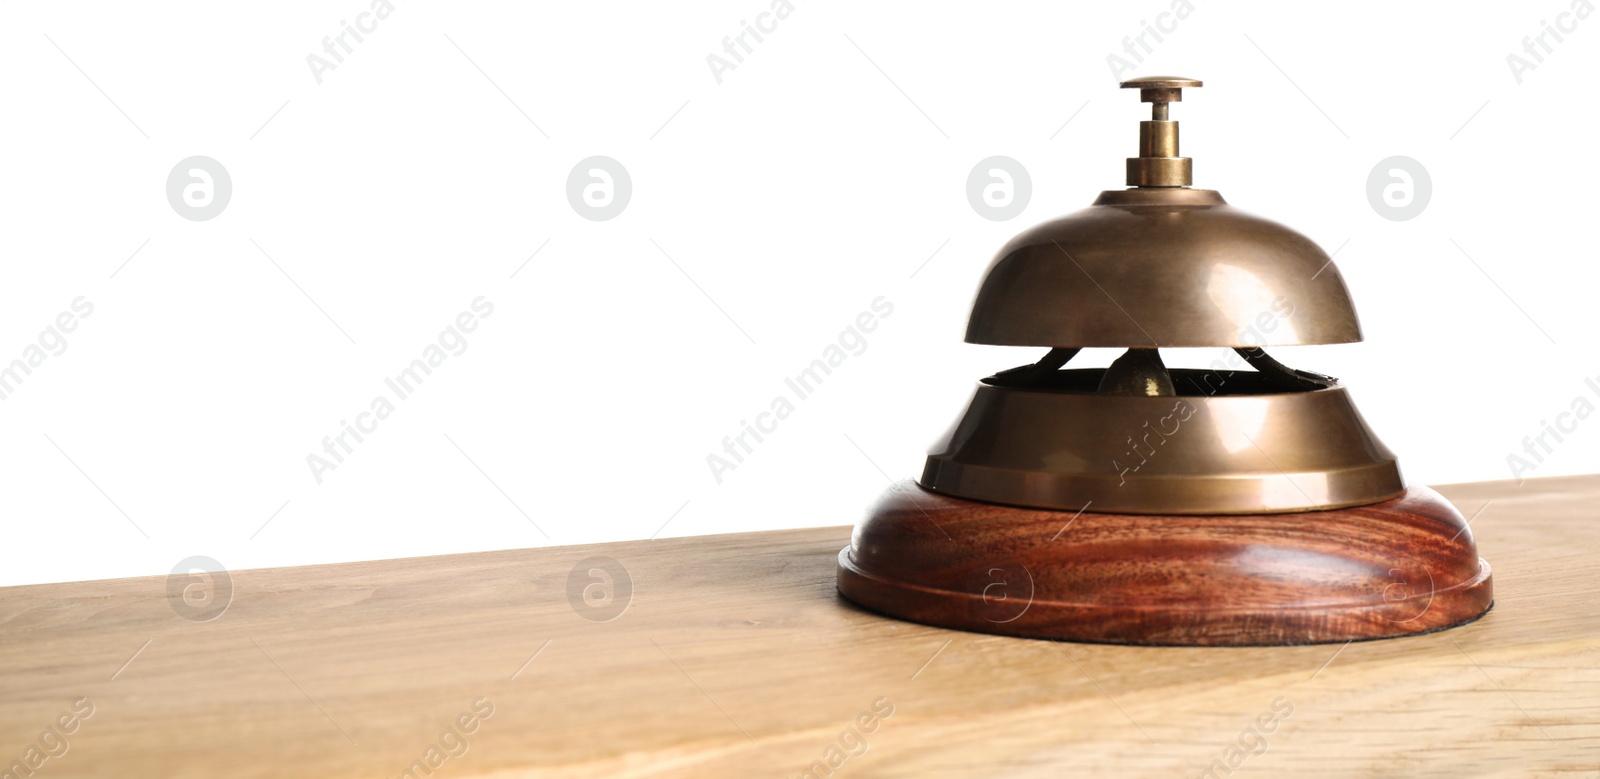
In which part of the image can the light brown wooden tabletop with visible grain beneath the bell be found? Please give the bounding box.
[0,477,1600,779]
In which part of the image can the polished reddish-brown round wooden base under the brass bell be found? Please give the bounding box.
[838,481,1494,646]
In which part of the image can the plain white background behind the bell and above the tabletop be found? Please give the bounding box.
[0,0,1600,584]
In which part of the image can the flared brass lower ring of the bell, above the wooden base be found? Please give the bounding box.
[920,370,1405,513]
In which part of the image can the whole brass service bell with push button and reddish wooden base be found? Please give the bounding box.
[838,77,1493,646]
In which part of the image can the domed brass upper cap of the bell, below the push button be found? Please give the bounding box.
[966,189,1362,349]
